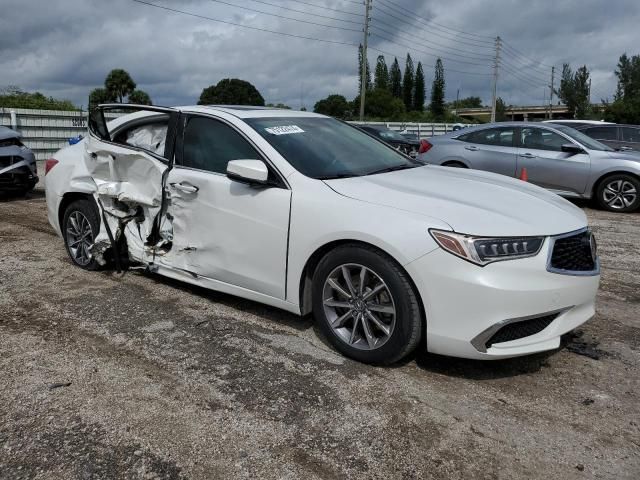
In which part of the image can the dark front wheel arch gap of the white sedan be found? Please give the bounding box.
[299,239,426,333]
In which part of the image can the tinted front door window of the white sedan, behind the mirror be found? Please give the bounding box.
[182,117,260,174]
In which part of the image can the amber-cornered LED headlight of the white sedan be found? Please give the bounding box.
[429,229,545,265]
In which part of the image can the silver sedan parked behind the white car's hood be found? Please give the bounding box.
[418,122,640,212]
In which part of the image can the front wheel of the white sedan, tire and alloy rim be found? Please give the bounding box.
[312,244,423,364]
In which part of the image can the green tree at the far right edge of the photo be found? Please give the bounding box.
[604,53,640,124]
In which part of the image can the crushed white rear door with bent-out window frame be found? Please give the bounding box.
[84,104,179,263]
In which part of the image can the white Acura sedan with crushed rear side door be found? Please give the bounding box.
[45,105,600,363]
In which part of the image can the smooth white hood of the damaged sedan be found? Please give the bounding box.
[326,165,587,236]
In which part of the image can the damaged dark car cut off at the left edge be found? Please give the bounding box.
[0,127,38,193]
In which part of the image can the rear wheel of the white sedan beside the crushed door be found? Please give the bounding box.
[62,200,100,270]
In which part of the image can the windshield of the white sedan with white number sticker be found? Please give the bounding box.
[246,117,421,180]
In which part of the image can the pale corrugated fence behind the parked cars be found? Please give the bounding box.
[0,106,454,160]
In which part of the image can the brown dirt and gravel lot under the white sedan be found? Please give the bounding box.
[0,192,640,479]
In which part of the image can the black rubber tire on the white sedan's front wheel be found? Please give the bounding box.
[312,244,424,365]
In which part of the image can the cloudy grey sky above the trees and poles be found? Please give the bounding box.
[0,0,640,109]
